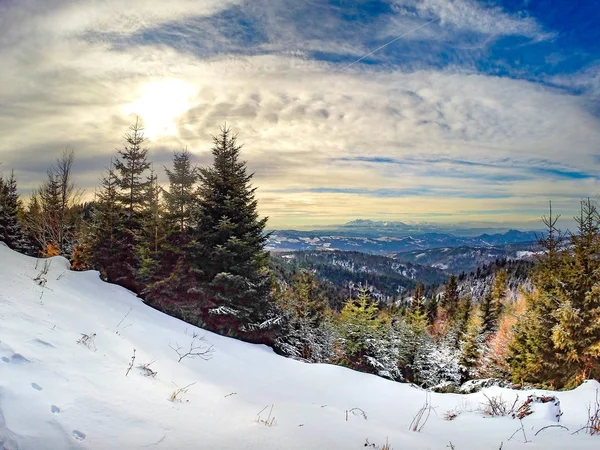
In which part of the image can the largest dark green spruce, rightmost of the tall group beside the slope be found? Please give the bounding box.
[188,127,274,343]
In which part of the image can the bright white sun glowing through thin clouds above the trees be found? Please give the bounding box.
[123,79,195,141]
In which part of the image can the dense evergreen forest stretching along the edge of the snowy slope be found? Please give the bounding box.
[0,122,600,391]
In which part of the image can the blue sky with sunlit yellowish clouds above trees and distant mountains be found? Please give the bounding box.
[0,0,600,227]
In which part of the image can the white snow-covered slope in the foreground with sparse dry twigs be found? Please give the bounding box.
[0,243,600,450]
